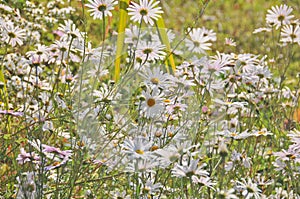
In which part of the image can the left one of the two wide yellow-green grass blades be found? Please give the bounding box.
[114,0,129,82]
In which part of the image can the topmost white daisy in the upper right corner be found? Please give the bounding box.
[266,4,294,29]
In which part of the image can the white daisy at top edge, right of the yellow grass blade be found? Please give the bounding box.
[127,0,163,26]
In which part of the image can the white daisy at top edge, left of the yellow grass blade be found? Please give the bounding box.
[86,0,118,19]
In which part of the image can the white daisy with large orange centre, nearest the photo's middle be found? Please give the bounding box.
[141,88,164,118]
